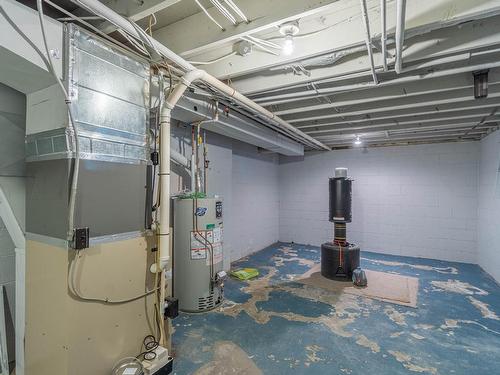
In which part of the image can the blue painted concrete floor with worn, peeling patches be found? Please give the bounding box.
[173,243,500,375]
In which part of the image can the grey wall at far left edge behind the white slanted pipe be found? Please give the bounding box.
[0,84,26,368]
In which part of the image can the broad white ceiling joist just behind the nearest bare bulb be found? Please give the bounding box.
[189,0,500,79]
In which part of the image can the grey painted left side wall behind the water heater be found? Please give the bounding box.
[171,123,279,270]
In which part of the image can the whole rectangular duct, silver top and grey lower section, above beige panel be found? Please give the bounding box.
[26,25,150,240]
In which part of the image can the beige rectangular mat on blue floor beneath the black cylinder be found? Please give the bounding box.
[295,264,418,308]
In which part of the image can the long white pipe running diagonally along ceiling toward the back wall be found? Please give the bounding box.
[72,0,330,150]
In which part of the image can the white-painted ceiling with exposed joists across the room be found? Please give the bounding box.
[85,0,500,147]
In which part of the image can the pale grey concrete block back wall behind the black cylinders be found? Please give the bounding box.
[279,142,479,263]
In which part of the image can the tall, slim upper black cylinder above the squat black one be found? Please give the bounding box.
[329,177,352,223]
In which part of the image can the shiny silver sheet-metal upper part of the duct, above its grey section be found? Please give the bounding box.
[26,24,149,163]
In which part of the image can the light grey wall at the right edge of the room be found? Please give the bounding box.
[478,131,500,283]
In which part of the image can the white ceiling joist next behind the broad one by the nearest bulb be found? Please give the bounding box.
[232,16,500,95]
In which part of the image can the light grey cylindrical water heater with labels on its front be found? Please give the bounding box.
[173,196,225,312]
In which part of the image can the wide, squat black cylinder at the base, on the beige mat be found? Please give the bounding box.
[321,242,359,280]
